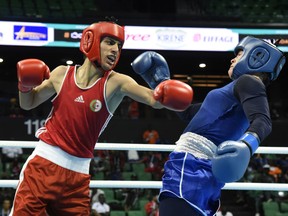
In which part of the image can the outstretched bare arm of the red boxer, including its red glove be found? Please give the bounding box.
[106,73,193,112]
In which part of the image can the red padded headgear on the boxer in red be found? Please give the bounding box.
[80,21,124,69]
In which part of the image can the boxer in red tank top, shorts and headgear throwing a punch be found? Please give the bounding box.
[11,21,193,216]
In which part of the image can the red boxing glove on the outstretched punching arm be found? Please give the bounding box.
[153,80,193,111]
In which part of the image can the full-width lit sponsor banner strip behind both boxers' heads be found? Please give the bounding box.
[0,21,288,51]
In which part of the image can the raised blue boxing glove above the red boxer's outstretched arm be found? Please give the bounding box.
[131,51,170,89]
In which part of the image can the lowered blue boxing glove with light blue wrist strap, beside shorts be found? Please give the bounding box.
[212,132,260,183]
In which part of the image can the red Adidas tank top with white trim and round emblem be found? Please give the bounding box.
[36,66,112,158]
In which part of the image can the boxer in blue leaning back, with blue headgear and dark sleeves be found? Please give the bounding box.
[132,36,286,216]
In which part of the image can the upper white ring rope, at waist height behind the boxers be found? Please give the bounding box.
[0,140,288,154]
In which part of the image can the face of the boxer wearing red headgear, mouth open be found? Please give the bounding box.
[100,37,122,71]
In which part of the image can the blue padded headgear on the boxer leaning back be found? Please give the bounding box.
[232,36,286,80]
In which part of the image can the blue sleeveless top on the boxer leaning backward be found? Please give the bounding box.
[183,80,249,146]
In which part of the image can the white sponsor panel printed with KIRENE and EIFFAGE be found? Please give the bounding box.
[123,26,239,51]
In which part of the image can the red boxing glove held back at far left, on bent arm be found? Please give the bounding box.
[17,59,50,93]
